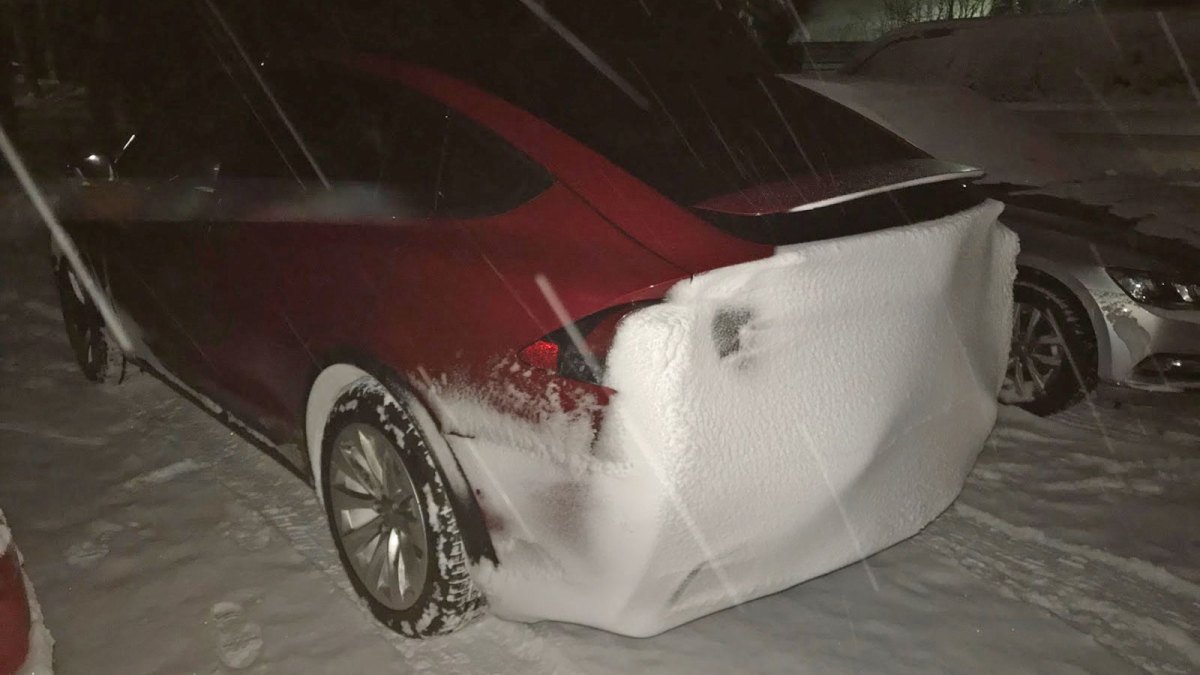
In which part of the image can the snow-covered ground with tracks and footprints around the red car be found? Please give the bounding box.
[0,229,1200,675]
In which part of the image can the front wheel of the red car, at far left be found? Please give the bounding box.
[54,259,134,384]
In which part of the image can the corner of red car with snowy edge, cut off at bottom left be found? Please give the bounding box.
[0,512,54,675]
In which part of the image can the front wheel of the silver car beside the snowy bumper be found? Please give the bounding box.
[1001,274,1099,416]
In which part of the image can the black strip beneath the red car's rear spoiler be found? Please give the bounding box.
[694,181,985,246]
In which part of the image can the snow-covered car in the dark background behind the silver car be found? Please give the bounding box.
[842,8,1200,173]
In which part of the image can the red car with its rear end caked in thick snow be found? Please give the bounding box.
[56,4,1015,635]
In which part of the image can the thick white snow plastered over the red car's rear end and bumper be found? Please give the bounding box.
[428,198,1016,635]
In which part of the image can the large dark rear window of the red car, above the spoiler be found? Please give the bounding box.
[388,0,924,204]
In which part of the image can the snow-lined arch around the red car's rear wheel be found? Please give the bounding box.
[304,353,497,563]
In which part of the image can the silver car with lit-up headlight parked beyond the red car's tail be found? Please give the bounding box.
[790,76,1200,414]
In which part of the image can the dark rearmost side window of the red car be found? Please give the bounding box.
[271,67,552,217]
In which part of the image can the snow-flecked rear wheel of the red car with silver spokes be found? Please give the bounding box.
[320,378,484,638]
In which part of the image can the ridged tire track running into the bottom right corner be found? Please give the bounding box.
[922,504,1200,675]
